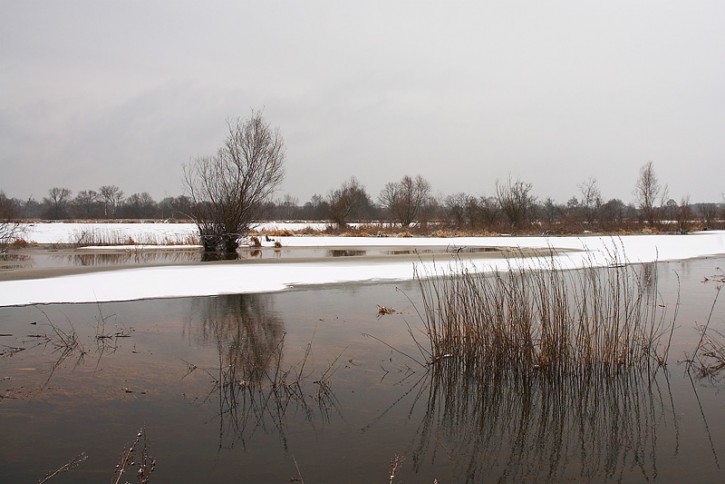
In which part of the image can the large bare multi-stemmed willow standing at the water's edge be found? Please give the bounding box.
[184,111,285,253]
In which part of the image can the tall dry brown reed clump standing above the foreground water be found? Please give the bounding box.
[418,255,677,381]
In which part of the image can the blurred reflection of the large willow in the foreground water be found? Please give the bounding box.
[189,294,336,449]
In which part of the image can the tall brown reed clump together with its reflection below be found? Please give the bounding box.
[394,265,679,482]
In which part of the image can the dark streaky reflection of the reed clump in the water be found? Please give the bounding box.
[413,359,678,482]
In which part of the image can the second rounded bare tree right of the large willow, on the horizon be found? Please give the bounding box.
[379,175,431,227]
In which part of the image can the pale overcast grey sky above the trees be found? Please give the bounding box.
[0,0,725,203]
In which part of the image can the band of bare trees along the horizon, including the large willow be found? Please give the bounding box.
[0,110,725,255]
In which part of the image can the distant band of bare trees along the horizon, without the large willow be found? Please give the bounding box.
[0,162,725,233]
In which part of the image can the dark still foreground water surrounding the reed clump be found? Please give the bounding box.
[0,259,725,483]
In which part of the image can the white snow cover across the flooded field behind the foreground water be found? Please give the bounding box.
[0,224,725,306]
